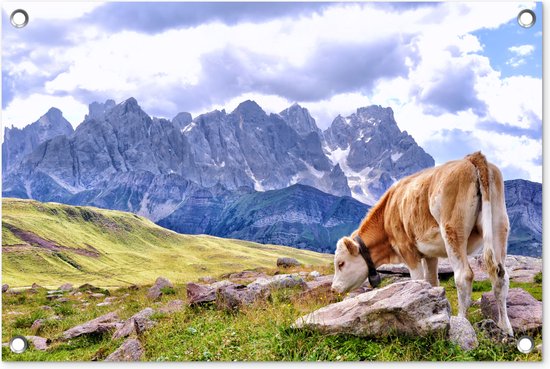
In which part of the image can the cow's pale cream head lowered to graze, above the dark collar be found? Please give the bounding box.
[332,237,369,293]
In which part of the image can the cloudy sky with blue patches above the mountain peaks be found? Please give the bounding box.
[2,1,542,182]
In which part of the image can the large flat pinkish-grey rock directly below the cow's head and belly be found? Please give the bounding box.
[292,281,451,337]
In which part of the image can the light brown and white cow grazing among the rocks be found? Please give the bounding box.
[332,152,513,335]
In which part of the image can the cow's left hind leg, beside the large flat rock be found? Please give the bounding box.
[441,226,474,318]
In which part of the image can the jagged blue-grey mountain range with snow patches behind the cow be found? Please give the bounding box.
[2,98,542,256]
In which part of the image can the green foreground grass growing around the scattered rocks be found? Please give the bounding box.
[2,266,542,361]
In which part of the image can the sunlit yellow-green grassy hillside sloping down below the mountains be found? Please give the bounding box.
[2,199,332,287]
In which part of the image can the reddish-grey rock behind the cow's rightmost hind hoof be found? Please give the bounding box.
[481,288,542,334]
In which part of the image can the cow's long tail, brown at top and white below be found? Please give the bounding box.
[466,151,504,278]
